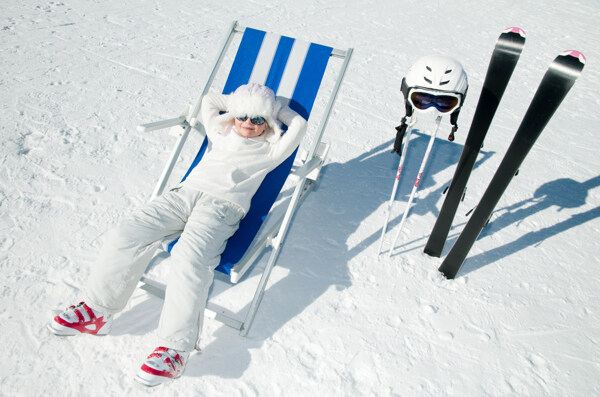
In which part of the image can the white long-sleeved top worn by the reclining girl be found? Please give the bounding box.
[184,94,306,213]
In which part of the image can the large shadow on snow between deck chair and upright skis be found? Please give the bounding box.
[185,130,491,378]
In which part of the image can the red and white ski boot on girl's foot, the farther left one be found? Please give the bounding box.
[48,302,112,336]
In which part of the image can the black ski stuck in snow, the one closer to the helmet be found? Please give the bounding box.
[424,28,525,258]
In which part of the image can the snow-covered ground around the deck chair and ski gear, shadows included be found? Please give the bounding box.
[0,0,600,396]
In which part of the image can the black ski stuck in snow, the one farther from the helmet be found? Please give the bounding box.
[439,51,585,279]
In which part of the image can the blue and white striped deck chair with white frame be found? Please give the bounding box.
[138,22,352,336]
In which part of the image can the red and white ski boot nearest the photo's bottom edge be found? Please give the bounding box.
[135,347,187,386]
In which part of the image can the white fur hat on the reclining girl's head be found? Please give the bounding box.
[217,83,282,142]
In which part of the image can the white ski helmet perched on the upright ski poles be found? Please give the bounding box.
[400,55,469,140]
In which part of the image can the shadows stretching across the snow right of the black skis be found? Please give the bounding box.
[454,176,600,274]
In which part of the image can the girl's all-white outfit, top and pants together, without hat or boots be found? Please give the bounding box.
[85,94,306,351]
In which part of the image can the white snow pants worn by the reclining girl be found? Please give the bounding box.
[85,185,244,351]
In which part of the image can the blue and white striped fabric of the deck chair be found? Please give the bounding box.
[176,28,332,274]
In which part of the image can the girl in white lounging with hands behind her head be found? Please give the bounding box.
[49,84,306,386]
